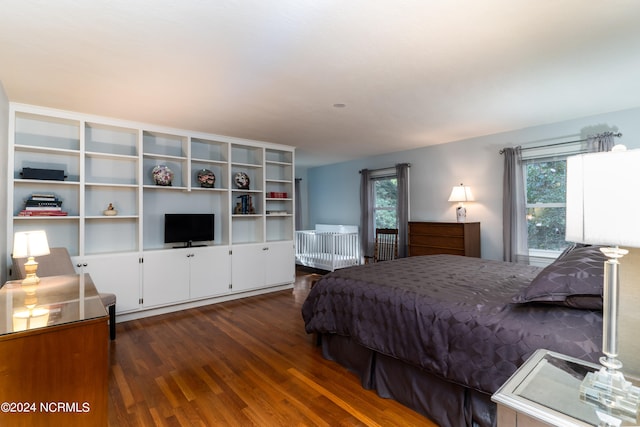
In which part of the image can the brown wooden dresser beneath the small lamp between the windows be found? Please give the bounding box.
[409,221,480,258]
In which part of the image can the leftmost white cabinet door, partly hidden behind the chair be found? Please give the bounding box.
[73,253,140,313]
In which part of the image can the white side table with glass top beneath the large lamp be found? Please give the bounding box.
[491,350,640,427]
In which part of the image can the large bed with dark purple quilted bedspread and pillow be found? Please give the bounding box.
[302,247,604,427]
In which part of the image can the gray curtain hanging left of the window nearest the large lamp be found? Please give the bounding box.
[502,147,529,262]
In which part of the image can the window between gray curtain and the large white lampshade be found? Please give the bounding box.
[524,157,567,254]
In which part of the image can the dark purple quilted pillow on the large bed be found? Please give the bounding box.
[513,246,607,310]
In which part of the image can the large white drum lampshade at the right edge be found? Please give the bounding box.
[566,145,640,247]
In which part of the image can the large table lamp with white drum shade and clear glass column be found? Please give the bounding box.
[566,145,640,421]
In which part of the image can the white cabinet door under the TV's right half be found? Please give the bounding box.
[189,246,231,299]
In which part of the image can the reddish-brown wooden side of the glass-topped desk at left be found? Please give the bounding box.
[0,316,108,426]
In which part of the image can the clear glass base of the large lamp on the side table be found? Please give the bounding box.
[580,367,640,422]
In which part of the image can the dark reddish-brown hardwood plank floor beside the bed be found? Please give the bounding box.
[109,271,434,427]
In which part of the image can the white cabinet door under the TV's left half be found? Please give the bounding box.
[142,248,192,307]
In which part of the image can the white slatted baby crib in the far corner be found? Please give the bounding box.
[296,224,360,271]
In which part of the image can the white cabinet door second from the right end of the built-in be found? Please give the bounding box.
[231,243,267,292]
